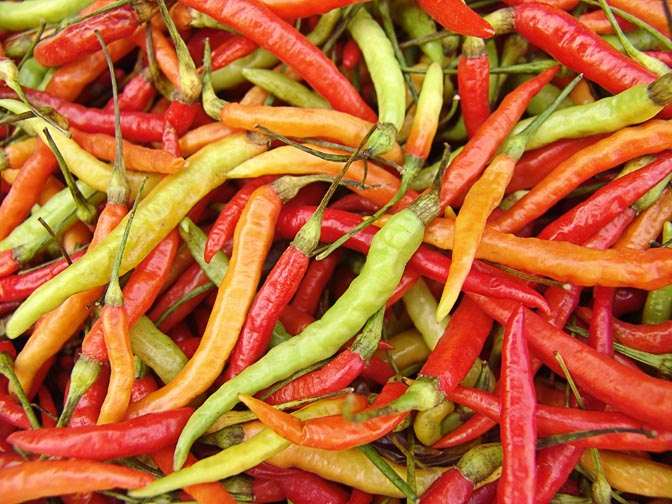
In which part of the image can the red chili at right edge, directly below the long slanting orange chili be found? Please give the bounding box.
[538,153,670,243]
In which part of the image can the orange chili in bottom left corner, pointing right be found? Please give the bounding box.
[0,460,154,504]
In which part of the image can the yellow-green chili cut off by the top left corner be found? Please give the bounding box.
[0,0,92,31]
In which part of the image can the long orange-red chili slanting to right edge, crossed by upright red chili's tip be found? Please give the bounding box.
[469,294,669,429]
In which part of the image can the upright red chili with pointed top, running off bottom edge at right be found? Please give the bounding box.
[497,305,537,502]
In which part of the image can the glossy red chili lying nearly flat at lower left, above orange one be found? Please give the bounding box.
[7,408,193,461]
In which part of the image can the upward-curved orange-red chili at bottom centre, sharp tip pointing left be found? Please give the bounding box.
[239,381,409,450]
